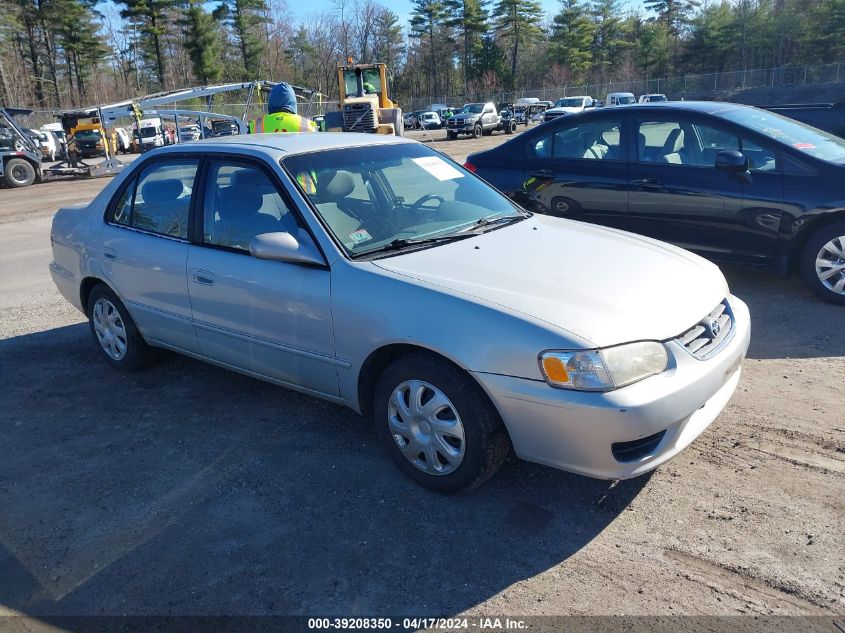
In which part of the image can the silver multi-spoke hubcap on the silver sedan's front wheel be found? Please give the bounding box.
[387,380,466,475]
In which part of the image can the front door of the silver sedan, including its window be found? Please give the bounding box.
[188,158,338,395]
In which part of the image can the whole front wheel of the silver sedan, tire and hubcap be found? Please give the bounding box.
[373,352,510,493]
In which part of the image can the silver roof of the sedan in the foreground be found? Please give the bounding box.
[159,132,414,154]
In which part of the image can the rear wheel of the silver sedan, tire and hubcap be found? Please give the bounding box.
[86,284,154,372]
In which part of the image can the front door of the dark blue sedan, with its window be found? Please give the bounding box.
[628,115,782,265]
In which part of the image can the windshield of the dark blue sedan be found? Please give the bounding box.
[717,108,845,163]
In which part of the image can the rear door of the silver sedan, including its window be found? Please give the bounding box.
[101,157,199,353]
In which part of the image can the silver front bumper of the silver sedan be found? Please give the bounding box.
[473,297,751,479]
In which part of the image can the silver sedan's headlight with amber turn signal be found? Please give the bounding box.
[539,341,669,391]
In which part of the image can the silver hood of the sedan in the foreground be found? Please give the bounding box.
[374,216,728,347]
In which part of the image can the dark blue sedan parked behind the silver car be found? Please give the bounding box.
[466,102,845,304]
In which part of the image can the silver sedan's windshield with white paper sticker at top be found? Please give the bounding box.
[282,143,524,257]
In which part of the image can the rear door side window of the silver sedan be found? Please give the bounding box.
[111,159,199,239]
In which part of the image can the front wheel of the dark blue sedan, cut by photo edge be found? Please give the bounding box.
[799,221,845,305]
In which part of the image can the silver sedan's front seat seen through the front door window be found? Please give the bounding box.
[210,185,283,250]
